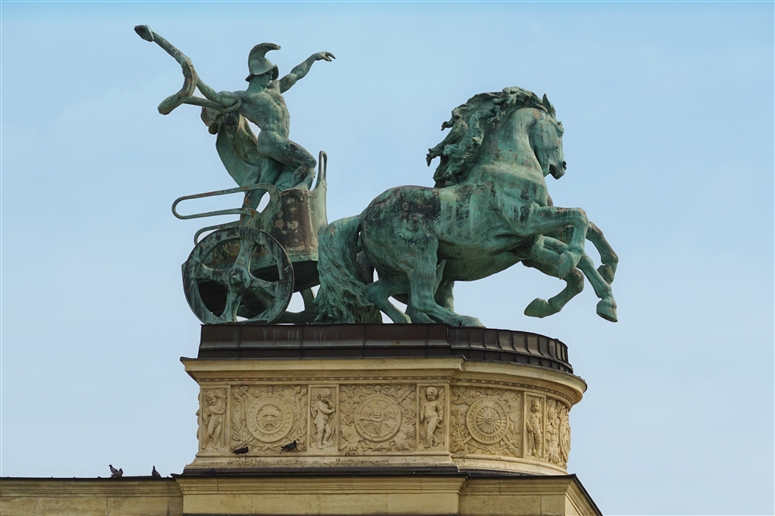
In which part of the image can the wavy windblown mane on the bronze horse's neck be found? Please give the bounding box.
[426,86,555,188]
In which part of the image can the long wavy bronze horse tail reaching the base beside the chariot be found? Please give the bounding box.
[315,216,382,323]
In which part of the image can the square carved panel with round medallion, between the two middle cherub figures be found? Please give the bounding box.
[339,384,416,454]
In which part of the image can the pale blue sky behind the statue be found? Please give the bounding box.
[0,2,775,514]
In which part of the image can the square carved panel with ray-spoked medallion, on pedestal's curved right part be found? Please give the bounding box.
[450,387,522,457]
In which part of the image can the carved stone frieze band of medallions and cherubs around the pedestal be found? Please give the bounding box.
[190,362,572,475]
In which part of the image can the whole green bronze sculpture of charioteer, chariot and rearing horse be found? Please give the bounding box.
[135,25,618,326]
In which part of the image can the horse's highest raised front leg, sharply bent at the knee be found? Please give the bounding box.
[524,205,589,279]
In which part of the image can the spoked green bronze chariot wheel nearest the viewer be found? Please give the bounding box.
[182,226,294,324]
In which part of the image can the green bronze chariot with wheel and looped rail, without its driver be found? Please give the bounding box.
[172,152,328,324]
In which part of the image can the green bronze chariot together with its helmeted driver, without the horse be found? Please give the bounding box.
[135,25,334,324]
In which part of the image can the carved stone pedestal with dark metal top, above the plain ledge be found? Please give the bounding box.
[181,324,586,477]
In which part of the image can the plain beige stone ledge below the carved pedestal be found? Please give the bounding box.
[0,473,600,516]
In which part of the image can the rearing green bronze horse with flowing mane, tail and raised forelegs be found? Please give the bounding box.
[315,87,618,326]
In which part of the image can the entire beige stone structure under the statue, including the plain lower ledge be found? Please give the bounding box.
[0,324,600,516]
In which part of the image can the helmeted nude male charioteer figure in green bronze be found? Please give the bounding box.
[197,43,334,189]
